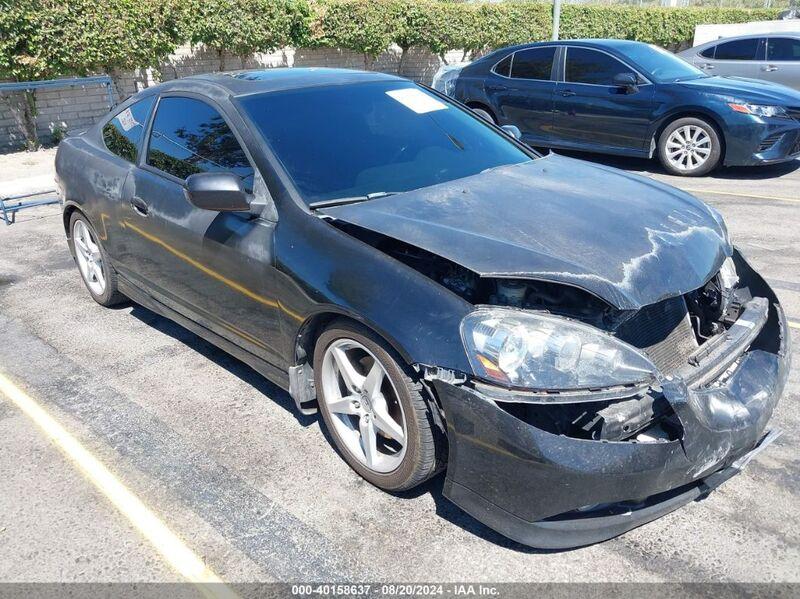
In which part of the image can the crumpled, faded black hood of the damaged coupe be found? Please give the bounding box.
[323,154,732,309]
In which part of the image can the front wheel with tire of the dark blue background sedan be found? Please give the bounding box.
[658,117,722,177]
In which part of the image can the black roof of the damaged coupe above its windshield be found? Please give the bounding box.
[176,67,406,96]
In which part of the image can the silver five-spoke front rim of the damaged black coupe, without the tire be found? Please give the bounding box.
[321,339,407,473]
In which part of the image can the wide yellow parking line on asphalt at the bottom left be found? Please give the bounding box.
[0,374,236,597]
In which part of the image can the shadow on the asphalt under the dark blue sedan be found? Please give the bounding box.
[553,150,800,181]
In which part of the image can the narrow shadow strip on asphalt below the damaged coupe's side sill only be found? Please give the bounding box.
[128,304,316,427]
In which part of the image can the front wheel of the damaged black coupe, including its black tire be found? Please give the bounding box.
[314,320,436,491]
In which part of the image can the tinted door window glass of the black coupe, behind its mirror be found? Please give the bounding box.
[147,98,254,192]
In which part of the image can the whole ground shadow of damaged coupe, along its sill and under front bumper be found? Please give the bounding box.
[125,302,564,554]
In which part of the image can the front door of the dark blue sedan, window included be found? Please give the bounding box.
[553,46,655,154]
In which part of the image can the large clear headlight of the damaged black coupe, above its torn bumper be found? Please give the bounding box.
[461,308,656,391]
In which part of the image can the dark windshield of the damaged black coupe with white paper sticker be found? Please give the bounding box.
[241,81,531,204]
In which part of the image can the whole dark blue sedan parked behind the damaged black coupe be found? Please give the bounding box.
[445,40,800,176]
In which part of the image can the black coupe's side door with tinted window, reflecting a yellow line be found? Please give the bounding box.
[117,95,281,366]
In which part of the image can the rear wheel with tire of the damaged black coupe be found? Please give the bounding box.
[69,211,126,307]
